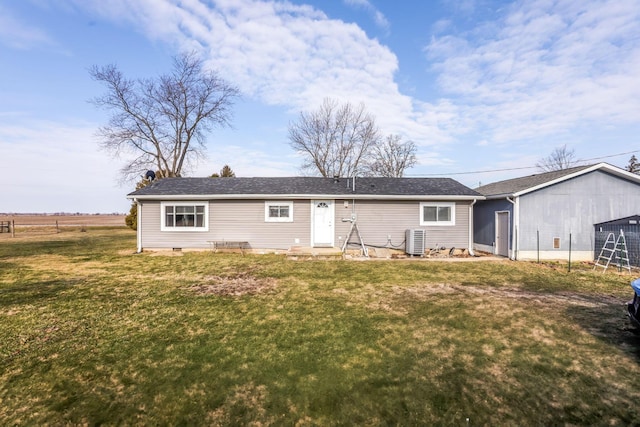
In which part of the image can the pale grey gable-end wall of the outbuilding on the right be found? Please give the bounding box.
[519,171,640,251]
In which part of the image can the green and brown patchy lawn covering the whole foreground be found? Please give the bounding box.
[0,228,640,426]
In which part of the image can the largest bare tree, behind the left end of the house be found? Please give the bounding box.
[89,53,239,181]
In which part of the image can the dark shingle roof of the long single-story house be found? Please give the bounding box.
[128,177,481,199]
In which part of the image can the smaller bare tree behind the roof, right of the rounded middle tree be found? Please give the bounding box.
[367,135,418,178]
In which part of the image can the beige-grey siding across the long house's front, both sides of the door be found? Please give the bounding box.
[139,199,470,249]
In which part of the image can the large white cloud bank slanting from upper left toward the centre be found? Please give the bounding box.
[67,0,450,144]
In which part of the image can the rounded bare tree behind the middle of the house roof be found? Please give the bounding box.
[289,98,380,177]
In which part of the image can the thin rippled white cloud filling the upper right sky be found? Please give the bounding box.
[426,0,640,143]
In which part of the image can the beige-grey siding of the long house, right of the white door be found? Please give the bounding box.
[336,200,469,249]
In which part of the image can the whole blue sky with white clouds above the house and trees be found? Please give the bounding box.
[0,0,640,213]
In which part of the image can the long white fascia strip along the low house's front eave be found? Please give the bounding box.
[127,194,485,201]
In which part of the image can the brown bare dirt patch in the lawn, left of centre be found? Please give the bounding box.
[192,273,276,297]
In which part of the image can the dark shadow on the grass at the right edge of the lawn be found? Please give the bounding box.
[566,295,640,363]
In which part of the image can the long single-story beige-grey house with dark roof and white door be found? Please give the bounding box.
[127,177,483,251]
